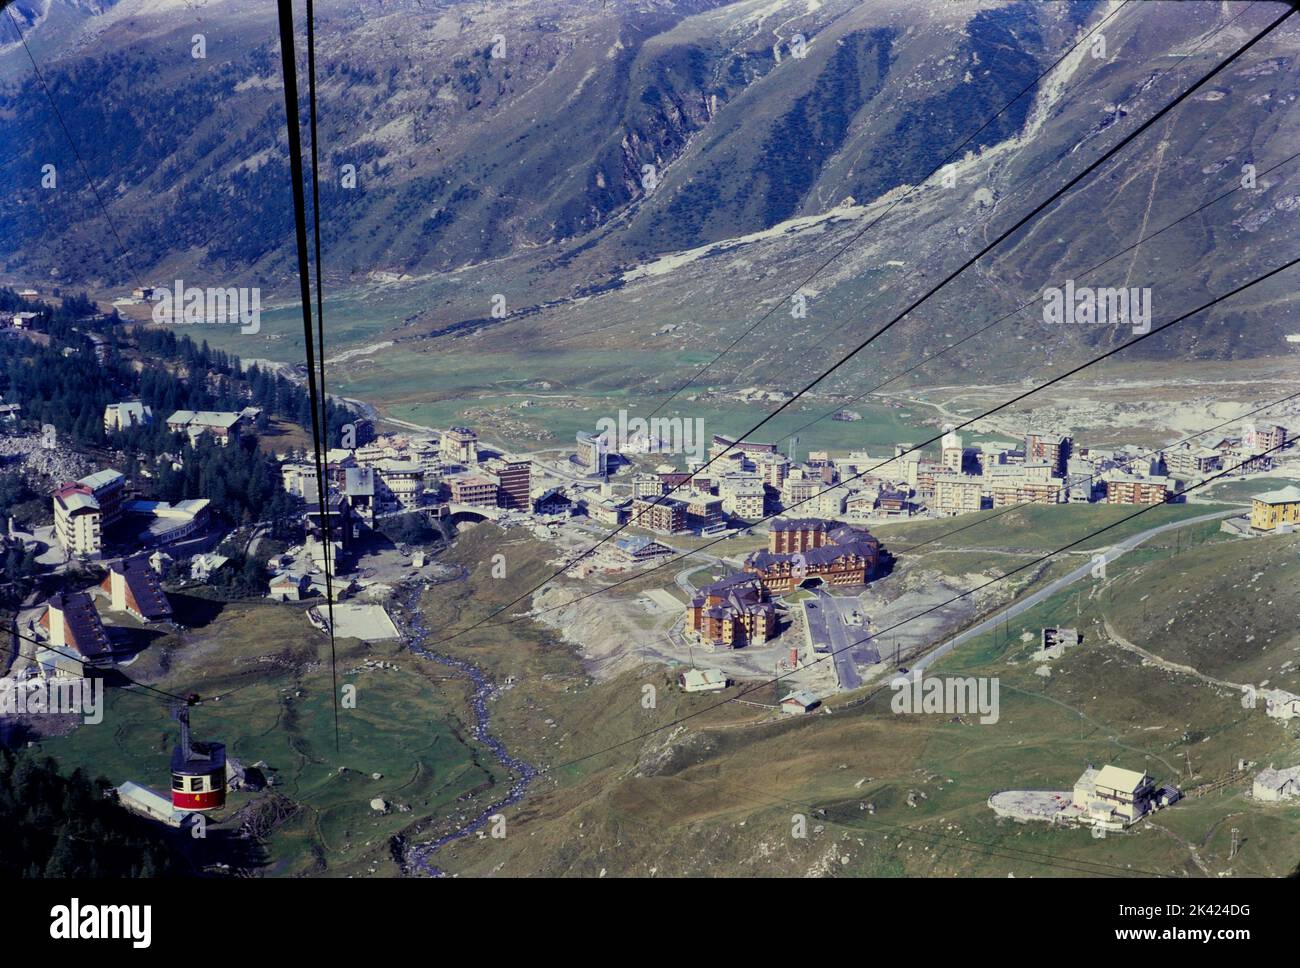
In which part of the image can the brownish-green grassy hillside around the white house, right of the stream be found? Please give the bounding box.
[421,509,1300,877]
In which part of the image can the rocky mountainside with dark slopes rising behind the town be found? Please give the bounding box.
[0,0,1300,379]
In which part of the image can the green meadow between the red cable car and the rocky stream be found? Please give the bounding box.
[40,596,503,876]
